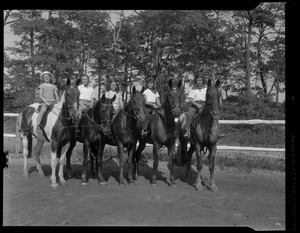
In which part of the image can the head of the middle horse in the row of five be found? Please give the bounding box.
[131,86,146,121]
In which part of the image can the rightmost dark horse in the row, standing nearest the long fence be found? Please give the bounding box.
[178,79,222,191]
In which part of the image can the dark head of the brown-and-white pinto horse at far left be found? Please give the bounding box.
[65,79,80,119]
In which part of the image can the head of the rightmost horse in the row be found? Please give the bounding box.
[205,79,222,118]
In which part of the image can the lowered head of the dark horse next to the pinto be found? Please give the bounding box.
[100,93,116,135]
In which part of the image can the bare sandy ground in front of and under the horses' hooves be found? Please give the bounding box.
[3,155,285,230]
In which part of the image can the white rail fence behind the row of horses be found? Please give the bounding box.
[4,113,285,152]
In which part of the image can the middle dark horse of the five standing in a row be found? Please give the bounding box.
[94,87,146,186]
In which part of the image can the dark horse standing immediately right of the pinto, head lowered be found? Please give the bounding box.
[78,94,116,185]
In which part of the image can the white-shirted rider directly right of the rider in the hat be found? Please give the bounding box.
[75,74,93,138]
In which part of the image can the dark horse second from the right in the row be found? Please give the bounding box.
[133,79,183,186]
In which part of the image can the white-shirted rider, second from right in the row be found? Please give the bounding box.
[142,75,161,137]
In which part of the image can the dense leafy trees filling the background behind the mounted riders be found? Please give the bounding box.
[4,3,285,113]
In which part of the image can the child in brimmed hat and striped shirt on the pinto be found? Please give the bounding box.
[37,71,59,136]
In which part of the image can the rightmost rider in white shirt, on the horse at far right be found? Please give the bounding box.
[184,74,224,139]
